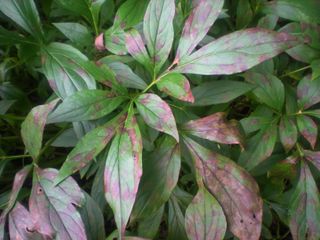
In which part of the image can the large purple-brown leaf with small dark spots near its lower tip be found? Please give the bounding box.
[184,137,262,240]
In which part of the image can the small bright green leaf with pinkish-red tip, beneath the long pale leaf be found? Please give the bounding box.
[157,73,194,103]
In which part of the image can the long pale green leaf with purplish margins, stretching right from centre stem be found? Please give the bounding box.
[175,28,299,75]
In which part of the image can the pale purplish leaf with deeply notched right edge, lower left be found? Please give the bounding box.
[29,169,87,240]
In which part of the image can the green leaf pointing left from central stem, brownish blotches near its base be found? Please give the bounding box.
[48,89,124,123]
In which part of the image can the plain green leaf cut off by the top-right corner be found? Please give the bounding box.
[262,0,320,23]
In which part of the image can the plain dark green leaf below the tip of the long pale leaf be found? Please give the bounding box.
[245,72,285,112]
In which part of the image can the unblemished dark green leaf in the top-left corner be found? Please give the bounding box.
[0,0,44,41]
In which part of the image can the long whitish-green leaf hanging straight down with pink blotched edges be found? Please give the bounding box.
[104,112,142,236]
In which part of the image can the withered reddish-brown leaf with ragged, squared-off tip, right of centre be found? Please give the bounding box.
[183,112,241,144]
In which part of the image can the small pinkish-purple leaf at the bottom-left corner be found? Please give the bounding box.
[9,203,43,240]
